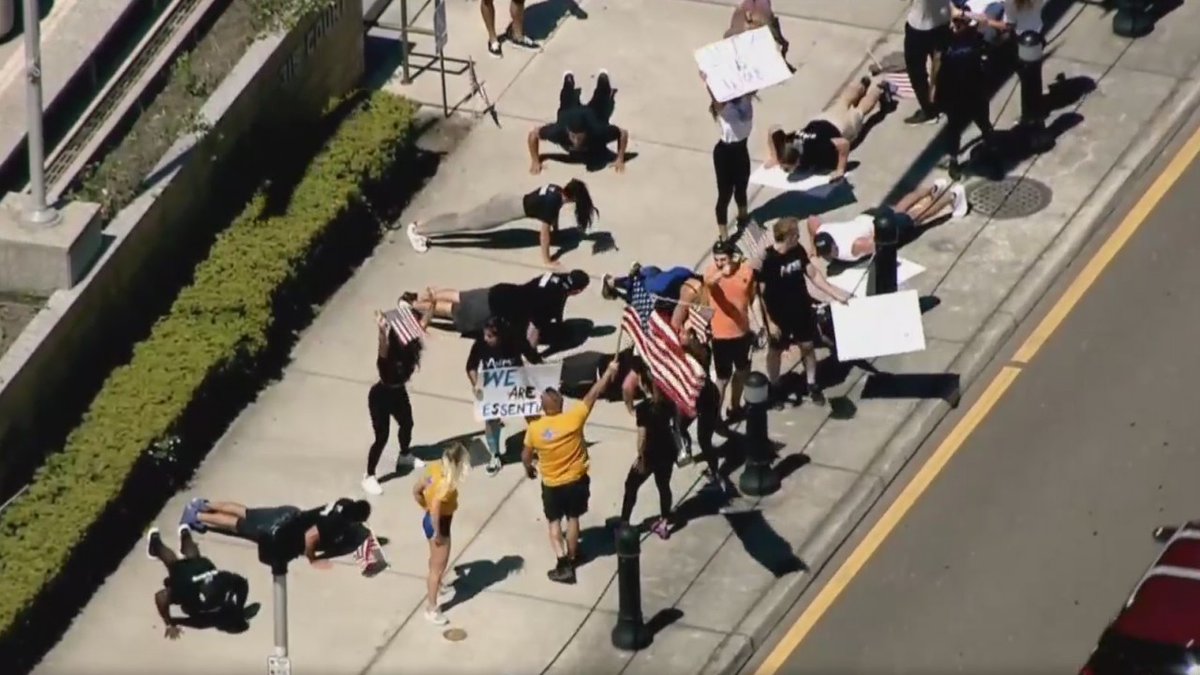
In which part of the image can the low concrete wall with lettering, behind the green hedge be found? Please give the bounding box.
[0,0,364,489]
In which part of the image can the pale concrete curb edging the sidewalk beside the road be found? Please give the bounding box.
[703,67,1200,675]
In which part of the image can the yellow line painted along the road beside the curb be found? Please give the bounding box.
[755,115,1200,675]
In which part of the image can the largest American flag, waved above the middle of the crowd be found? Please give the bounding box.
[622,275,704,417]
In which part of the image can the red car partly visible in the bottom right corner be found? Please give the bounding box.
[1080,521,1200,675]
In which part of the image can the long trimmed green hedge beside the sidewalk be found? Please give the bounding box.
[0,92,415,635]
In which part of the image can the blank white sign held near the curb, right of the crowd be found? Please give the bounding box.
[832,291,925,363]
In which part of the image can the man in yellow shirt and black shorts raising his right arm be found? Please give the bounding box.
[521,359,618,584]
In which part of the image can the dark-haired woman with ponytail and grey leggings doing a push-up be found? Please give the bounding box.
[407,179,600,269]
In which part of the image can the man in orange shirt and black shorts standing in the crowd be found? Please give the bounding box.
[704,239,756,419]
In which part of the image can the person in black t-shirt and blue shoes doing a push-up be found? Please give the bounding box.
[180,497,371,569]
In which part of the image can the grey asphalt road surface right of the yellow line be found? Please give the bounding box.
[746,117,1200,675]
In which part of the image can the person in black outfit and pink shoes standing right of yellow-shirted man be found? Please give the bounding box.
[620,369,677,539]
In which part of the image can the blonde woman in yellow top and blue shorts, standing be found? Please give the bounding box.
[413,443,470,626]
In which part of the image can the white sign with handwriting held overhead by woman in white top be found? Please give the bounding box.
[695,26,792,103]
